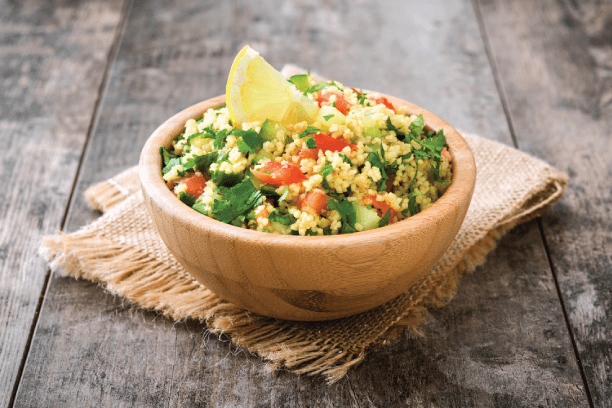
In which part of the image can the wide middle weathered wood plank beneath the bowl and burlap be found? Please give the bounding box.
[17,0,586,407]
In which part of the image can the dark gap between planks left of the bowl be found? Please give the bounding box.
[8,0,134,408]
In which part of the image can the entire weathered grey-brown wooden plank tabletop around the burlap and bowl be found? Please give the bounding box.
[0,0,612,407]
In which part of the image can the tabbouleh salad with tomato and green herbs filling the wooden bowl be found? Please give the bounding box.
[160,75,452,235]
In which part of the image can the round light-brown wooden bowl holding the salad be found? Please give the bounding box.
[140,95,476,320]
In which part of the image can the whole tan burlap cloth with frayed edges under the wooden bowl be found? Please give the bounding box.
[41,135,567,383]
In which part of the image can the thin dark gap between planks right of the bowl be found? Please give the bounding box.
[472,0,594,408]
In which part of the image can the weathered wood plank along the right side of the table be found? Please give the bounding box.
[481,0,612,407]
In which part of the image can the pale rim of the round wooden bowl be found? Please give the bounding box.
[139,93,476,245]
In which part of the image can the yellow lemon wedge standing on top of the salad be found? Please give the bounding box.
[226,45,319,126]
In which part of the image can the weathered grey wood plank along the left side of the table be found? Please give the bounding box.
[0,1,122,407]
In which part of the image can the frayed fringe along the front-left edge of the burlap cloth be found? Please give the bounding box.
[40,231,365,384]
